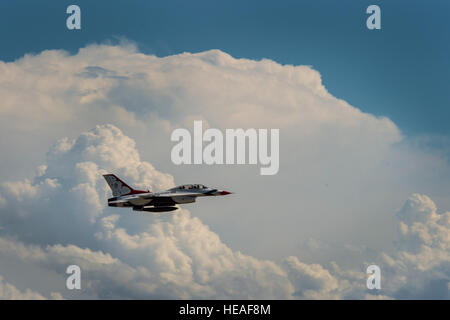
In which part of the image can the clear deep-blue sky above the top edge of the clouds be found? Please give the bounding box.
[0,0,450,136]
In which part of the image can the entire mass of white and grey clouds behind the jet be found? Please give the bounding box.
[0,44,450,299]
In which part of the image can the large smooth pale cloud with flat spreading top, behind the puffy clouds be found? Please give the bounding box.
[0,45,450,260]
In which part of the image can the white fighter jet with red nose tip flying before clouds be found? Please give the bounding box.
[103,174,231,212]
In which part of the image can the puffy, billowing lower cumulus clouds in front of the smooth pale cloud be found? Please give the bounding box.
[0,125,450,299]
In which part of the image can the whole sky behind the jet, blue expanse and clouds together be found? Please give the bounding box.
[0,1,450,299]
